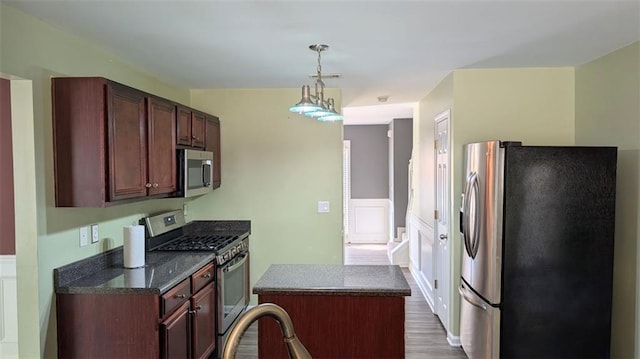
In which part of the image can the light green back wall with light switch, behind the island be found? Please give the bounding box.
[188,89,343,303]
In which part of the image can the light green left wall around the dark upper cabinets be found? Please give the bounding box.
[0,5,189,358]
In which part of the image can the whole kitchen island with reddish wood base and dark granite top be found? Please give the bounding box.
[253,264,411,358]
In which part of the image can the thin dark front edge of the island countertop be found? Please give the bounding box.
[253,288,411,297]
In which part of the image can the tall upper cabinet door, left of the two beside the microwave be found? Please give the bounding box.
[107,82,147,201]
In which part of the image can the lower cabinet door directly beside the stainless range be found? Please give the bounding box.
[191,282,217,359]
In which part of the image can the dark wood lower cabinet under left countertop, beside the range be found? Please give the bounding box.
[56,264,217,359]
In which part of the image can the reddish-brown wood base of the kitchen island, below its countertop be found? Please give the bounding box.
[258,294,405,359]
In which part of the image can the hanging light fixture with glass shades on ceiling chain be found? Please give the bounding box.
[289,44,344,122]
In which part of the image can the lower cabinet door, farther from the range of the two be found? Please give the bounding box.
[160,301,191,359]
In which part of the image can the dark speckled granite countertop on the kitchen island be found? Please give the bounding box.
[253,264,411,296]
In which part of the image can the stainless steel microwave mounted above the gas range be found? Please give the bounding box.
[177,149,213,197]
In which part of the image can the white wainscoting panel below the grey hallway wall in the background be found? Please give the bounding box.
[348,198,389,243]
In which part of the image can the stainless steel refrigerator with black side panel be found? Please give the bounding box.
[459,141,617,359]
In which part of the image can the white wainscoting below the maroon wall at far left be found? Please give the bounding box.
[0,255,18,359]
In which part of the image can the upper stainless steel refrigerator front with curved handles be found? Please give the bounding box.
[460,141,504,304]
